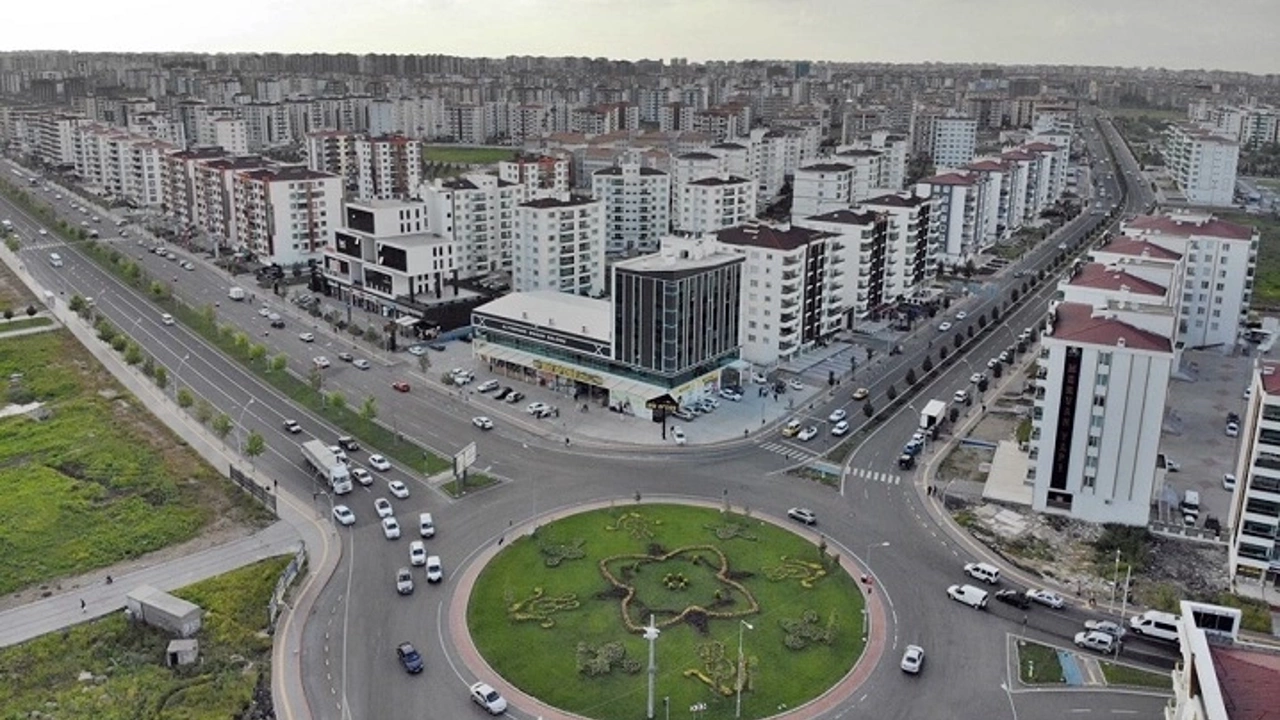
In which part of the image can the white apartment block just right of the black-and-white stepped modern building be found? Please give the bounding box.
[422,174,526,278]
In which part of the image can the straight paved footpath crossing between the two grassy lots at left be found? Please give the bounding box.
[0,520,300,647]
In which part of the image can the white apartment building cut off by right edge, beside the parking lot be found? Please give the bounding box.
[1226,361,1280,588]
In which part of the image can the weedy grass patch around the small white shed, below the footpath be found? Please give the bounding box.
[0,557,292,720]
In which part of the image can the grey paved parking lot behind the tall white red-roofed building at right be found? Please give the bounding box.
[1157,350,1253,527]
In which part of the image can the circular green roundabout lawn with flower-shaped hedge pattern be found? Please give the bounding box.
[467,503,864,720]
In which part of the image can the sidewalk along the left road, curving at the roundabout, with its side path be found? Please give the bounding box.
[0,245,342,720]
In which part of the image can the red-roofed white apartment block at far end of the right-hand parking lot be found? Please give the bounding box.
[1121,213,1260,347]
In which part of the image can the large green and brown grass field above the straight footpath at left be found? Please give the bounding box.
[0,331,266,594]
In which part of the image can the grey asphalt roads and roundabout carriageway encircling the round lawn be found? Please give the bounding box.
[0,107,1172,720]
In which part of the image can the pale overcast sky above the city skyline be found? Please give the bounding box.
[10,0,1280,73]
